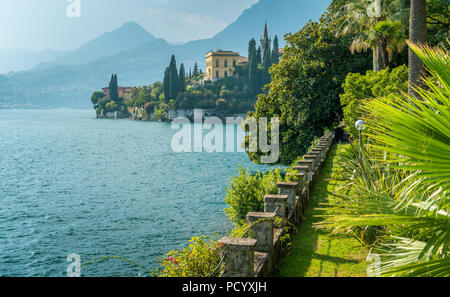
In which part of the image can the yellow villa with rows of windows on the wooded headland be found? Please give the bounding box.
[205,50,240,82]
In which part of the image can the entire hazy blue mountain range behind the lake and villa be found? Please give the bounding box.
[0,0,331,108]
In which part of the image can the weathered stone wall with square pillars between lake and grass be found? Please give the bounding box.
[219,131,336,277]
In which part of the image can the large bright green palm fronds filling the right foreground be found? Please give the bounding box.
[321,44,450,276]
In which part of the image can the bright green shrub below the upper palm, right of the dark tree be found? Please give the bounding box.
[340,66,408,138]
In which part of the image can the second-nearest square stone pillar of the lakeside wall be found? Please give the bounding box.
[247,212,276,255]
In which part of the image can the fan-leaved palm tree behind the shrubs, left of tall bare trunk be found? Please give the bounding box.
[333,0,406,71]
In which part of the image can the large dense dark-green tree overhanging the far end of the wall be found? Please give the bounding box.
[249,14,371,164]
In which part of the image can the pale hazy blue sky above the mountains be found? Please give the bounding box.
[0,0,258,51]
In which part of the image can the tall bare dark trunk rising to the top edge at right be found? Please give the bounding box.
[408,0,427,96]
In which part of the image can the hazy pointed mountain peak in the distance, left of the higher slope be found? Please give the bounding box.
[44,22,156,65]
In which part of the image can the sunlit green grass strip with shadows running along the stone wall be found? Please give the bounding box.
[278,144,369,277]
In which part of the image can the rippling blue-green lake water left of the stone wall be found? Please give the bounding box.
[0,110,274,276]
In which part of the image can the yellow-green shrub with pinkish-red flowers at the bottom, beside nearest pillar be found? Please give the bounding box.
[155,236,220,277]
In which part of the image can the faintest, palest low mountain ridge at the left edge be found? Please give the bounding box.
[0,49,69,73]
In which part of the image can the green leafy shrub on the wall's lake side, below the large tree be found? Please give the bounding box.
[225,167,283,226]
